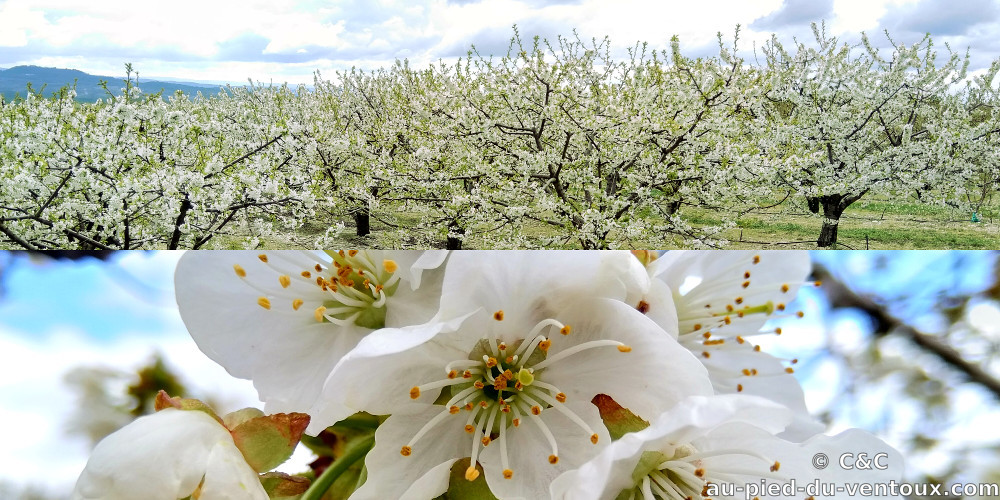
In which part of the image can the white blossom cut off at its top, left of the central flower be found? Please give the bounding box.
[175,250,447,433]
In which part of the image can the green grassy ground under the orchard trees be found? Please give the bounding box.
[240,197,1000,250]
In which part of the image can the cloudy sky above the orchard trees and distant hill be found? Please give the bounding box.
[0,0,1000,83]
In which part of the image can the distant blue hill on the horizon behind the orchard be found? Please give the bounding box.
[0,66,227,102]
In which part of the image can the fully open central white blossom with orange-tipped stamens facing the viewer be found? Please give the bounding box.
[330,252,711,498]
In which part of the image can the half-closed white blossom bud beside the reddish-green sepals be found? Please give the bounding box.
[72,408,268,500]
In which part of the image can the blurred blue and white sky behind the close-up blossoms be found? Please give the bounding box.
[0,252,1000,496]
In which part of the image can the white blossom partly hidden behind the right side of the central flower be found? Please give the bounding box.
[630,251,822,440]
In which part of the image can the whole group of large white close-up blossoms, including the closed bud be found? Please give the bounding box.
[76,250,902,500]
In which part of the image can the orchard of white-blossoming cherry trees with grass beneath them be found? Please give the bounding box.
[0,26,1000,249]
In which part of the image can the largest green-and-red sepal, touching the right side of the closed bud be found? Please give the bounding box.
[230,413,309,472]
